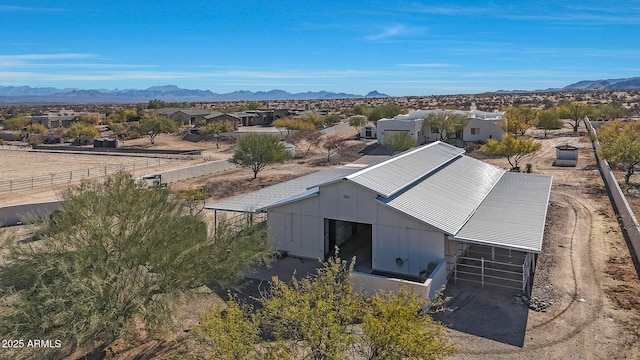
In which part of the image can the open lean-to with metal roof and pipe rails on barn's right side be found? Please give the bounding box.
[446,173,551,294]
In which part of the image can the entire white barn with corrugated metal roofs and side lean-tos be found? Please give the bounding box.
[205,142,551,297]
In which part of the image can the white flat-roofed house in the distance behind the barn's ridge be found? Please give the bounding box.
[377,104,505,144]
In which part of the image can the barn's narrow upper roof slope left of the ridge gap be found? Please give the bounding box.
[347,142,464,197]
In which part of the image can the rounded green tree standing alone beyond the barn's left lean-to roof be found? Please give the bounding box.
[229,133,289,179]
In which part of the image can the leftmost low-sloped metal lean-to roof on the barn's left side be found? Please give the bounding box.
[205,168,359,212]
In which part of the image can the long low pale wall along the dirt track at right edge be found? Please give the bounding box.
[585,118,640,273]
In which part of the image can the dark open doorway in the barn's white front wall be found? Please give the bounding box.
[324,219,372,272]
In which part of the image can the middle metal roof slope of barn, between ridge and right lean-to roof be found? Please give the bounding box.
[380,156,505,235]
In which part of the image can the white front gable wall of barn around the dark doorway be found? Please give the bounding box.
[268,180,445,276]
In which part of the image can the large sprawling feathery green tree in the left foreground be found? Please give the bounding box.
[0,173,271,358]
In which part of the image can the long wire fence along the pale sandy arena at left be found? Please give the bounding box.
[0,158,180,193]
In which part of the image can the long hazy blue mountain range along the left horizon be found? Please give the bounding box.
[0,85,388,104]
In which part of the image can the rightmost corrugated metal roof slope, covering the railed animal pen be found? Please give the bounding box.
[455,173,552,253]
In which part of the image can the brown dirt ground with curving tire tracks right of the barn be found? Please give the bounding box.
[444,123,640,359]
